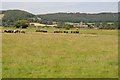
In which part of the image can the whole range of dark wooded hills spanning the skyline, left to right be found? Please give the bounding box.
[2,10,118,26]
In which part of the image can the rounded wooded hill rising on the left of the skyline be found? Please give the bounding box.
[2,10,35,25]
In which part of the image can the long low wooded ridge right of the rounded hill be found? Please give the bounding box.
[38,13,118,22]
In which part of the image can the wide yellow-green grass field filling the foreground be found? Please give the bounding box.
[2,29,118,78]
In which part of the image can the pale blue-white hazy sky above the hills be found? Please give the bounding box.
[1,0,118,14]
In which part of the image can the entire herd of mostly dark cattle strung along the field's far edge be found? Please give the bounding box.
[3,30,79,34]
